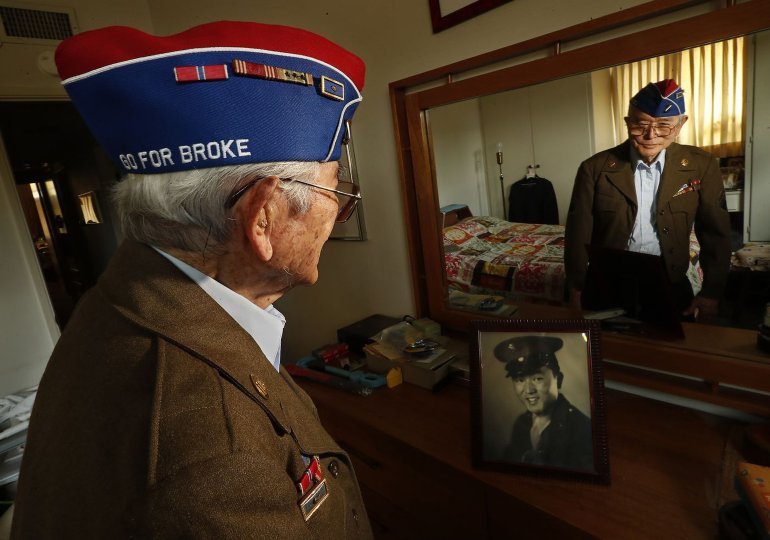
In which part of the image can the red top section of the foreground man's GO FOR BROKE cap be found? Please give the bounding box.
[56,21,365,91]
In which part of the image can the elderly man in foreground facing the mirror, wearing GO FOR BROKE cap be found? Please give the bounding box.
[12,22,371,539]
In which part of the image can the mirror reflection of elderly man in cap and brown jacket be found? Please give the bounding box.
[565,79,730,322]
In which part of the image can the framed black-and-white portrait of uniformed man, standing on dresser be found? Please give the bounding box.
[470,319,610,484]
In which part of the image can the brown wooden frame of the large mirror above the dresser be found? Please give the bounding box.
[390,0,770,417]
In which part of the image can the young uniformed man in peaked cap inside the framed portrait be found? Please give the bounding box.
[494,336,593,469]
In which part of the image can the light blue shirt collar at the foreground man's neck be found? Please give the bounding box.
[153,246,286,371]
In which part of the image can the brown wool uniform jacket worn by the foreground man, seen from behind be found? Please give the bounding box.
[12,241,372,540]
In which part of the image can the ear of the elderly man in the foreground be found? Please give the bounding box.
[236,176,280,261]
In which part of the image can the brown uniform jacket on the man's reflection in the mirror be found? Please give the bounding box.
[564,141,731,298]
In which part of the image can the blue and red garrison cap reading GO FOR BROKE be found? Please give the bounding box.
[56,21,365,174]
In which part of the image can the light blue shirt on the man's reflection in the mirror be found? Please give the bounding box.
[628,147,666,255]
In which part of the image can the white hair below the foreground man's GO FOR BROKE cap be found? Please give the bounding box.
[113,161,321,251]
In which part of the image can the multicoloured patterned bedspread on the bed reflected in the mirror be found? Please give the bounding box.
[443,216,703,303]
